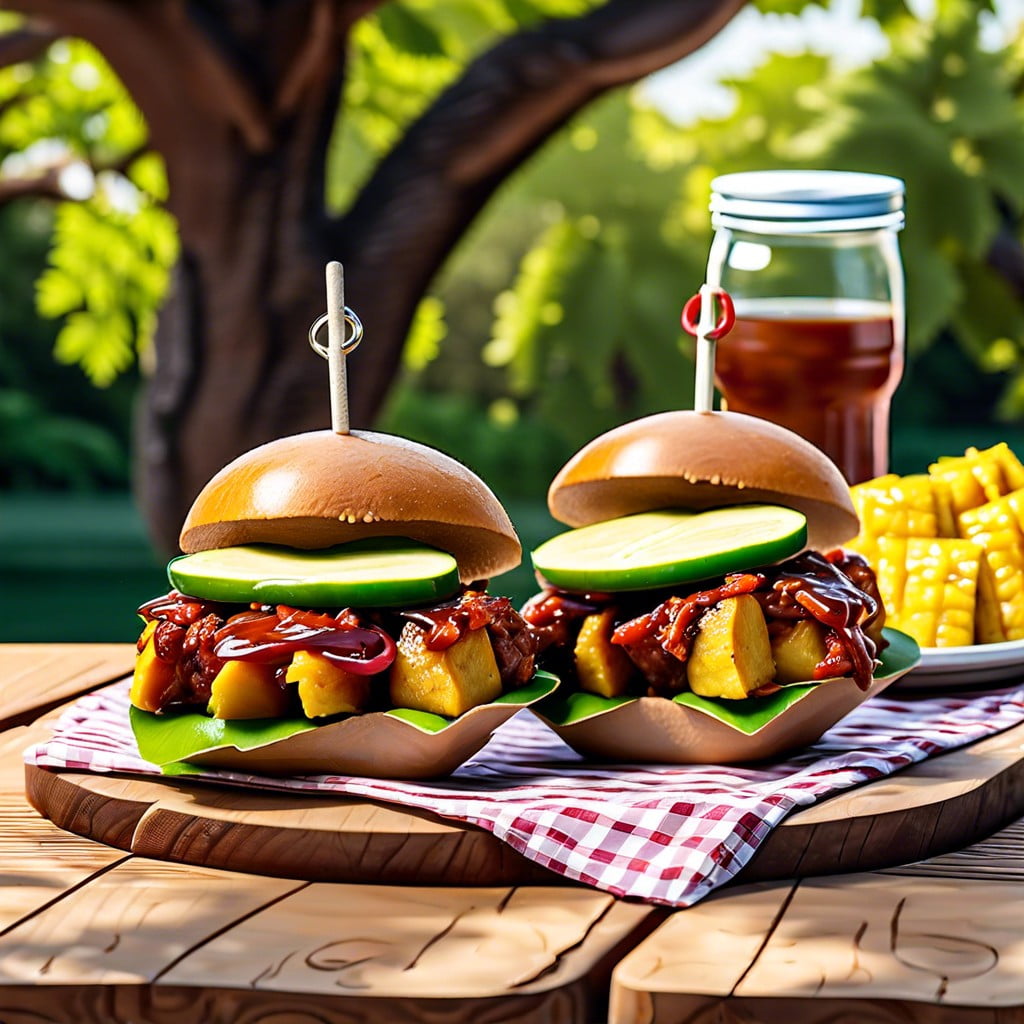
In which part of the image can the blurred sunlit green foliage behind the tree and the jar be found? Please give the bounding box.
[0,0,1024,640]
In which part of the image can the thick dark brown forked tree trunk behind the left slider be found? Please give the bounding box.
[10,0,745,553]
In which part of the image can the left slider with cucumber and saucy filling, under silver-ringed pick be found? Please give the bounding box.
[130,430,548,774]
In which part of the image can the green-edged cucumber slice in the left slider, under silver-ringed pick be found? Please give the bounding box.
[167,538,459,608]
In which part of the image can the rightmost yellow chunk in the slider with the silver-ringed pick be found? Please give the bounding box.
[391,623,502,718]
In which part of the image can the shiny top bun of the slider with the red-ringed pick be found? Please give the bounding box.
[548,412,859,551]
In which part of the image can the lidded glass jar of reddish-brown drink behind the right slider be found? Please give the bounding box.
[707,171,905,483]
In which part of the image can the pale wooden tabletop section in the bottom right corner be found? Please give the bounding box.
[609,873,1024,1024]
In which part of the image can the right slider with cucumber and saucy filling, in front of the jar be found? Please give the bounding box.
[523,412,887,710]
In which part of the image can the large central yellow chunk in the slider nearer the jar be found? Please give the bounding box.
[686,594,775,700]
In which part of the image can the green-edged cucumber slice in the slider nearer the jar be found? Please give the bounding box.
[532,505,807,592]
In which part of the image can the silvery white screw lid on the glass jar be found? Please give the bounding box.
[711,171,904,234]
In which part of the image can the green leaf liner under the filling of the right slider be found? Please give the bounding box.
[537,629,921,736]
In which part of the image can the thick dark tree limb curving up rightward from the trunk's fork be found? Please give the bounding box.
[328,0,745,423]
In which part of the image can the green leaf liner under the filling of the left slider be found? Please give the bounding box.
[129,672,559,775]
